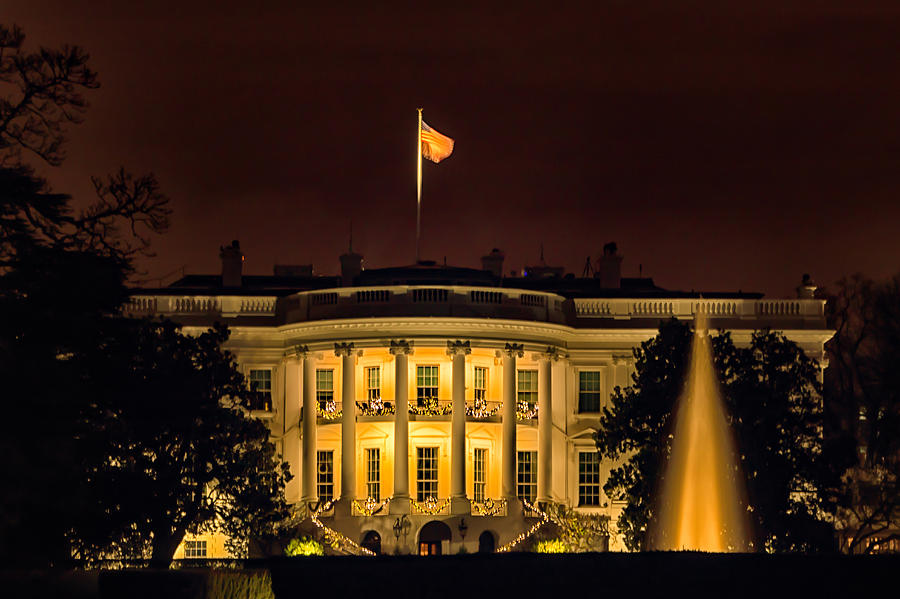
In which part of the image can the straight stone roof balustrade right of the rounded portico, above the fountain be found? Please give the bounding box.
[573,298,825,320]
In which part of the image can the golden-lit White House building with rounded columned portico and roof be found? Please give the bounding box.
[128,242,831,557]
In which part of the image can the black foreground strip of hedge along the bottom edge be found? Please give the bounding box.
[0,553,900,599]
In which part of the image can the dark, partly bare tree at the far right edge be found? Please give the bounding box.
[826,275,900,553]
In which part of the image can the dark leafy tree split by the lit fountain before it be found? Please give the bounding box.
[596,319,830,551]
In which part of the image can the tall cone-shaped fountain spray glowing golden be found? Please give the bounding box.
[649,306,750,552]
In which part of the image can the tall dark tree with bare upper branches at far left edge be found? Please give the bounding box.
[0,25,169,565]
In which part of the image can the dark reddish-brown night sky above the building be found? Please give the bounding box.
[7,0,900,296]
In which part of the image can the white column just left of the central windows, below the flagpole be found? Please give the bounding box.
[389,341,412,514]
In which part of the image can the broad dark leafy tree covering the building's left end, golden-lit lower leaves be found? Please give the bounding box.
[73,320,290,564]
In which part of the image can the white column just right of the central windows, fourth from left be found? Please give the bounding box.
[447,340,472,514]
